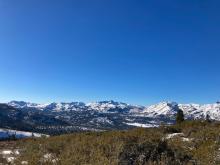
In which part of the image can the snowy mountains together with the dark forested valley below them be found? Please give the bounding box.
[0,101,220,133]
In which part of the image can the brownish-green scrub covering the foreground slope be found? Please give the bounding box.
[1,121,220,165]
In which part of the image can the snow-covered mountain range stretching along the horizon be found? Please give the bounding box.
[7,101,220,120]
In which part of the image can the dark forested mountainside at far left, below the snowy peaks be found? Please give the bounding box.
[0,104,68,132]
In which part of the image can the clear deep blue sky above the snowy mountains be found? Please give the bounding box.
[0,0,220,105]
